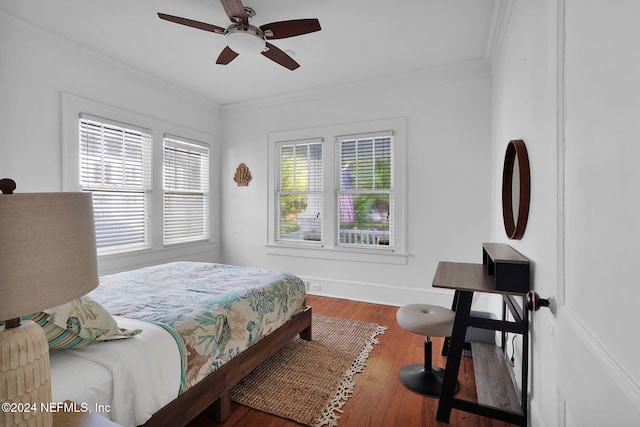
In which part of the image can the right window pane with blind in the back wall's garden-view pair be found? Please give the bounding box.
[336,132,394,247]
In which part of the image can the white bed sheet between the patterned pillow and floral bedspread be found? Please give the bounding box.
[49,316,182,427]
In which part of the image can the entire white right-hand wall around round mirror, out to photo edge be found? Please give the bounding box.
[491,0,640,427]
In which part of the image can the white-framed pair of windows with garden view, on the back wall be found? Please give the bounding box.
[267,118,407,264]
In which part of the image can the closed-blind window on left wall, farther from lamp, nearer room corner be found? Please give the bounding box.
[162,135,210,245]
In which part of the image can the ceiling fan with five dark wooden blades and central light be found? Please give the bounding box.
[158,0,320,70]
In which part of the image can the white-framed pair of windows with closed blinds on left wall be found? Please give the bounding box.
[62,93,219,272]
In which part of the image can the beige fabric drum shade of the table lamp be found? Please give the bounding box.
[0,193,98,320]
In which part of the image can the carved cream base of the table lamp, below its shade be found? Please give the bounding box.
[0,320,53,427]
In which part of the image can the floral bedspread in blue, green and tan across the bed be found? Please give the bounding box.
[90,262,306,390]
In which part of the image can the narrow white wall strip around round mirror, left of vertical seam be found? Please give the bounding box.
[491,0,557,426]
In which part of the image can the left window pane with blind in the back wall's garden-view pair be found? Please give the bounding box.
[275,140,324,242]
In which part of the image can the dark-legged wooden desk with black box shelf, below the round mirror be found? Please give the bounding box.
[433,243,530,426]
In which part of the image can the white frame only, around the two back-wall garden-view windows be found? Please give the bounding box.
[265,117,408,264]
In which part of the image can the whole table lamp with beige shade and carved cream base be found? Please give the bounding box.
[0,179,98,427]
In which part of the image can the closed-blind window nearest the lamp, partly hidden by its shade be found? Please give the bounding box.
[80,114,151,253]
